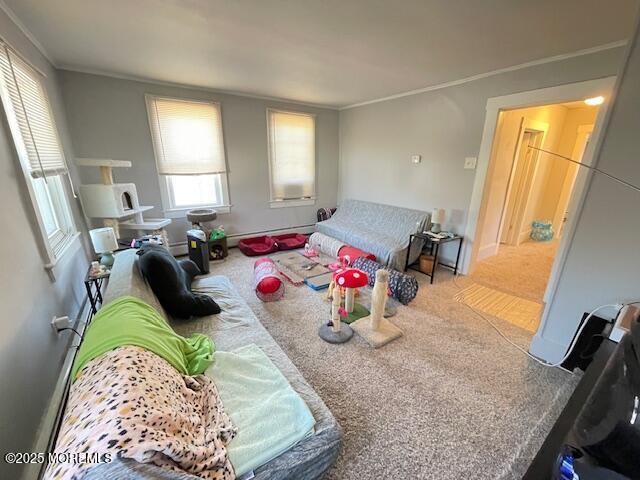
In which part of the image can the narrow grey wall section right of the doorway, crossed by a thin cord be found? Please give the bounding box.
[530,19,640,361]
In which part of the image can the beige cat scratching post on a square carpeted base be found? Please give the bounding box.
[351,269,402,348]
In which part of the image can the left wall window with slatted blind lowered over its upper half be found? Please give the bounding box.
[0,42,77,264]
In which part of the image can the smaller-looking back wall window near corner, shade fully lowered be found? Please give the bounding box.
[267,109,316,207]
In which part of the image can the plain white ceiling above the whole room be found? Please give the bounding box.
[5,0,637,106]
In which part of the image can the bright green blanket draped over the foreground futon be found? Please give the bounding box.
[71,297,215,380]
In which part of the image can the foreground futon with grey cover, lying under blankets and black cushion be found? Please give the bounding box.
[85,250,342,480]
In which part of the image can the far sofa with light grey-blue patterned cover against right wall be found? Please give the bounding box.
[316,199,430,270]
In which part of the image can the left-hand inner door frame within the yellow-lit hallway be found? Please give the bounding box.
[496,117,549,249]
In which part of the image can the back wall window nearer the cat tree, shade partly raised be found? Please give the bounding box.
[146,95,229,214]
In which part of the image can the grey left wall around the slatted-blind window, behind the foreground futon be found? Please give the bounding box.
[0,10,88,478]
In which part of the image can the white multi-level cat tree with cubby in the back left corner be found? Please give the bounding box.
[76,158,171,245]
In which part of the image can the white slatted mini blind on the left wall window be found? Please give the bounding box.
[0,43,67,177]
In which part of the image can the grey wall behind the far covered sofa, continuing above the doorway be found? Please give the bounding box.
[340,48,622,262]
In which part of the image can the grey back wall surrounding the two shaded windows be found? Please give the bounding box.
[60,70,338,243]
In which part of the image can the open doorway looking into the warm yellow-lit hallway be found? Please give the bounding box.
[462,89,602,334]
